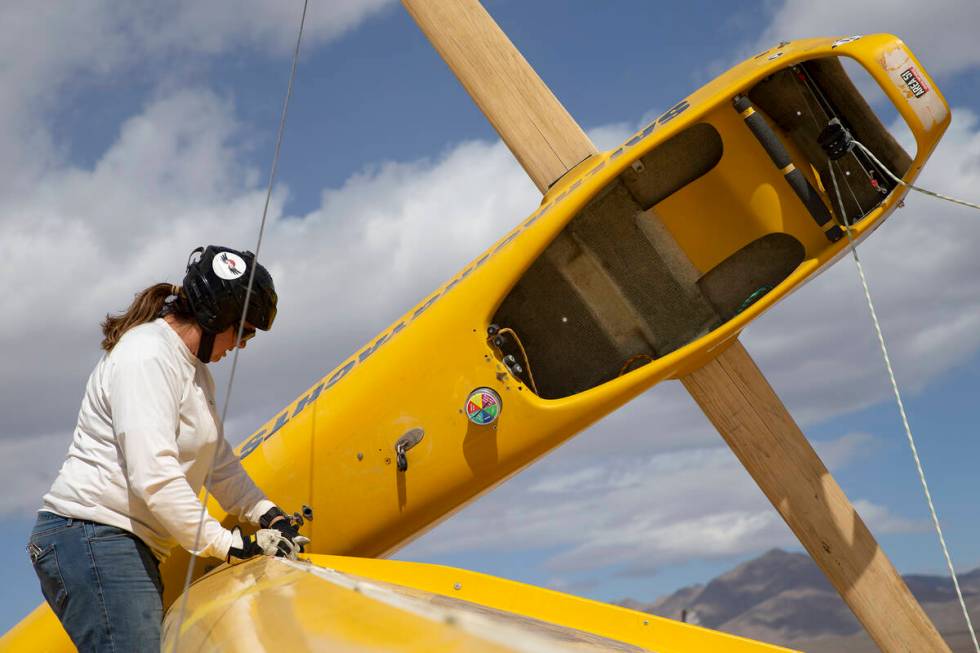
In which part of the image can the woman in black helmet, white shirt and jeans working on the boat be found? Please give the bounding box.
[28,246,307,653]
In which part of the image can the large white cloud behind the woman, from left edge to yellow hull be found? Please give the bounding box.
[0,89,537,509]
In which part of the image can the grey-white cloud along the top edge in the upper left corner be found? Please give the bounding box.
[0,0,396,90]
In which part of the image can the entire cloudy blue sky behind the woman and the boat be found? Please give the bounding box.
[0,0,980,629]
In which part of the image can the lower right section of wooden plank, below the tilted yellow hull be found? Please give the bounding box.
[681,341,949,652]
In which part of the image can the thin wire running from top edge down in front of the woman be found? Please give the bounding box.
[171,0,309,652]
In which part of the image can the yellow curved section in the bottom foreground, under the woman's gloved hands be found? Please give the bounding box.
[162,556,804,653]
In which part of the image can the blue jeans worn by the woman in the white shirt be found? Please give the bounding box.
[27,511,163,653]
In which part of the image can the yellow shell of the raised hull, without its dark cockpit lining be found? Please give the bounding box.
[218,35,949,568]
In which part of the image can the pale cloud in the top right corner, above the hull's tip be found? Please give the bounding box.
[755,0,980,74]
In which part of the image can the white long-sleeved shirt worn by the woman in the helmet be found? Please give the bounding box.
[41,319,275,560]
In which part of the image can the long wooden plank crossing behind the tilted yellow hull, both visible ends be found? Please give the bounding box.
[402,0,949,652]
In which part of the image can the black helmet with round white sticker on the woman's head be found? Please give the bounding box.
[183,245,278,363]
